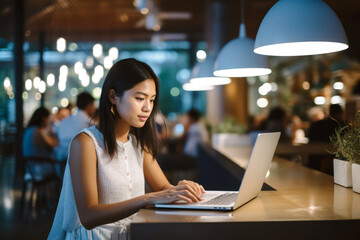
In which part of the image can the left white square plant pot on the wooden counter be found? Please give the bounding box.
[334,159,352,187]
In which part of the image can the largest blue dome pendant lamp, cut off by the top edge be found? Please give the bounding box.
[254,0,349,56]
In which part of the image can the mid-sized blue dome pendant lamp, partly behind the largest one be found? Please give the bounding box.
[214,1,271,77]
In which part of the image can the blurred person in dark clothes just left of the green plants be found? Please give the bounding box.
[309,104,345,143]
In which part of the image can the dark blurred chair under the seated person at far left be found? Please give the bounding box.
[20,157,61,220]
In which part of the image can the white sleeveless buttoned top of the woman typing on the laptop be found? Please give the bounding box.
[48,126,145,240]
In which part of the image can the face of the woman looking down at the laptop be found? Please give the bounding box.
[115,79,156,128]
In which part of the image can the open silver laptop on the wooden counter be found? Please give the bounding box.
[155,132,280,211]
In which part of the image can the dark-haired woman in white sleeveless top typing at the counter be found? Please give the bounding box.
[48,59,204,239]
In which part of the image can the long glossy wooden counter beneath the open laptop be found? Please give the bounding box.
[131,143,360,240]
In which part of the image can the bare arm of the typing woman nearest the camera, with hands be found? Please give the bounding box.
[69,133,204,229]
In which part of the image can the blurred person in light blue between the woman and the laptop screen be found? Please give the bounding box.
[183,109,209,158]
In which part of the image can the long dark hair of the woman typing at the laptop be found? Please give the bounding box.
[99,58,159,158]
